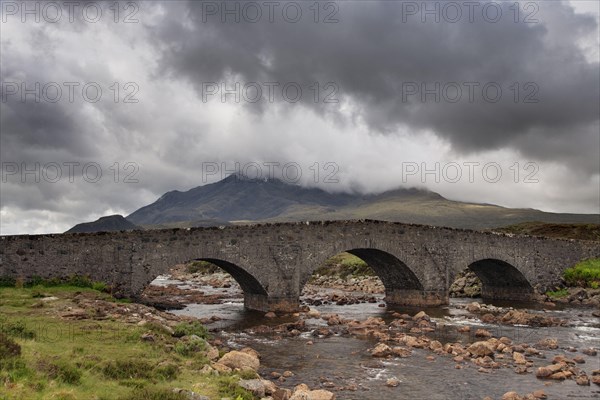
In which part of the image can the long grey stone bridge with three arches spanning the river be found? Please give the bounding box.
[0,220,600,311]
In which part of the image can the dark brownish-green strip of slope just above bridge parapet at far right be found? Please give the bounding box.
[493,222,600,241]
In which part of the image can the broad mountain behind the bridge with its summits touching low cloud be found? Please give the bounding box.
[127,175,600,229]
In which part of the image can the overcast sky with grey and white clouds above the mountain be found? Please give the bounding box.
[0,0,600,234]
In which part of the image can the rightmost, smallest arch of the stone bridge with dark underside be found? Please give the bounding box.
[467,258,535,300]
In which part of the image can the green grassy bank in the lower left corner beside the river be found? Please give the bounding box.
[0,286,253,400]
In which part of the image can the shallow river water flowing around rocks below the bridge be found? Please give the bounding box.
[153,276,600,400]
